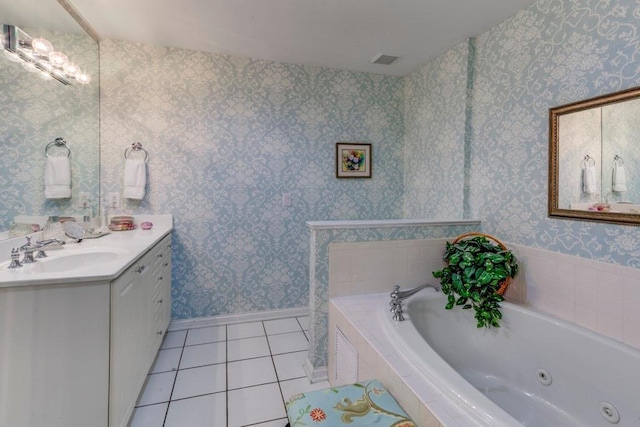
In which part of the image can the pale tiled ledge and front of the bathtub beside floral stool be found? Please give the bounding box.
[329,293,462,427]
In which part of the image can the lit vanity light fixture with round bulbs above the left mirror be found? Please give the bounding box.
[2,24,91,85]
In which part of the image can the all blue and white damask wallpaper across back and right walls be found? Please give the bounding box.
[95,0,640,319]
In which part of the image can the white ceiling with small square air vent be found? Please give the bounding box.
[71,0,534,76]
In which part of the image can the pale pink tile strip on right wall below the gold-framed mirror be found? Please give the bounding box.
[505,242,640,349]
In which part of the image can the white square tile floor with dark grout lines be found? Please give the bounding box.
[130,317,329,427]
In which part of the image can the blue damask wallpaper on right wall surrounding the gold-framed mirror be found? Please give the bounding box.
[469,0,640,268]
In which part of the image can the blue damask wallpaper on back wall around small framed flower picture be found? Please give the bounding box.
[100,40,404,319]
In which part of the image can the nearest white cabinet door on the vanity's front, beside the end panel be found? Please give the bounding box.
[109,257,151,427]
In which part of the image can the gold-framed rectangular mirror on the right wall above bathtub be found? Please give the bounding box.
[549,88,640,224]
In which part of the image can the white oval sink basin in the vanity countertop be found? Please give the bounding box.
[2,248,127,274]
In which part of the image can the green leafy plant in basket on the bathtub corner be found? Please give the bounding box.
[433,235,518,328]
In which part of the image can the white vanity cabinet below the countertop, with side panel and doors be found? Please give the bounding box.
[0,229,171,427]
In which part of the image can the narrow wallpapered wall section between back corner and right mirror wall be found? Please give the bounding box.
[404,42,469,219]
